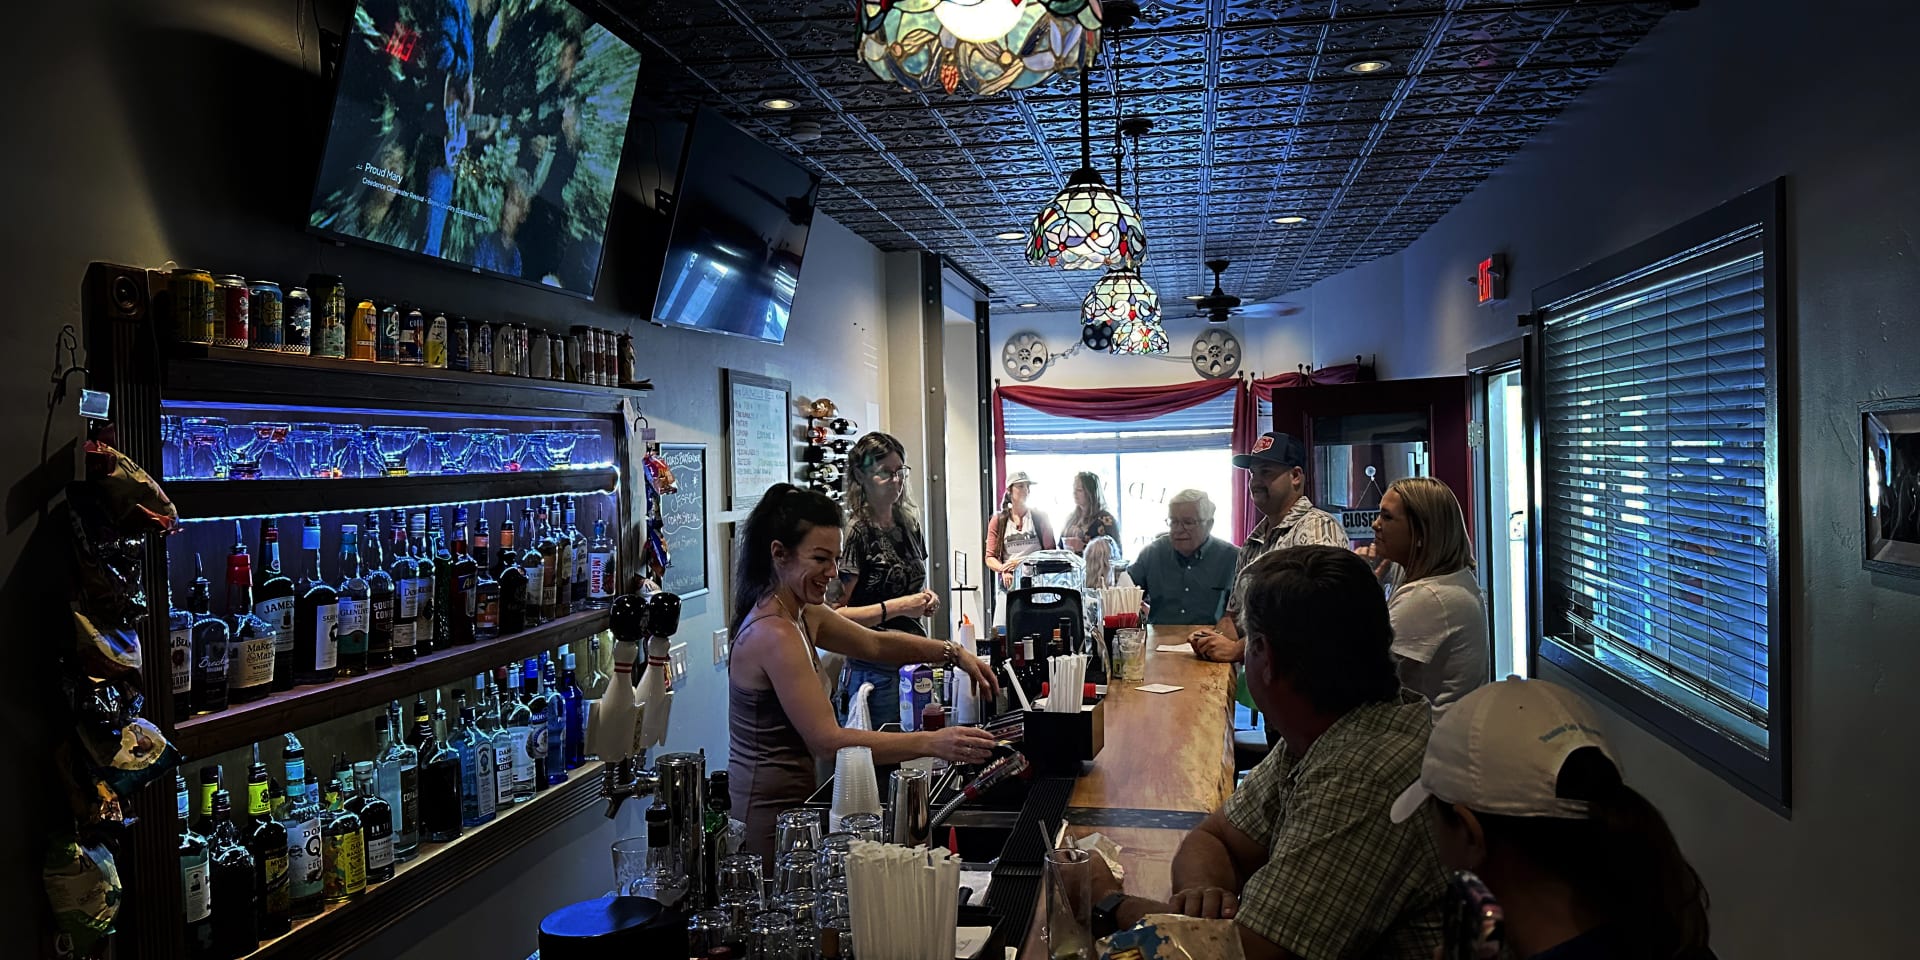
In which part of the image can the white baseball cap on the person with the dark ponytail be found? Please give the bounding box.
[1392,680,1613,824]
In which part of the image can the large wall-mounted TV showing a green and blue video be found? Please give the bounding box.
[307,0,639,298]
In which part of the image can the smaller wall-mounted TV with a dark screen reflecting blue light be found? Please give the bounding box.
[653,109,820,344]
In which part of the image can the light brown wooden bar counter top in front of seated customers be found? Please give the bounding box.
[1020,624,1235,958]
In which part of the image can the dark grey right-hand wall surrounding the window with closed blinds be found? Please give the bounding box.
[1244,0,1920,960]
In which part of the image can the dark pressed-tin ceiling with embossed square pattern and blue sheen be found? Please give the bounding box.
[605,0,1668,313]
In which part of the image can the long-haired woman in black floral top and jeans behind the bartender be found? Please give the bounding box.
[839,432,941,728]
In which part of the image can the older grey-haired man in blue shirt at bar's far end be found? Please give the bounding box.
[1127,490,1238,626]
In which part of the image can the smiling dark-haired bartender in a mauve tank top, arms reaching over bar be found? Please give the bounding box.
[728,484,996,856]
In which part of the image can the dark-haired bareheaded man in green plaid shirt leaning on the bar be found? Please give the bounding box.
[1092,545,1446,960]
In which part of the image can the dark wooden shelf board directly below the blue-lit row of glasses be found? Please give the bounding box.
[165,467,620,520]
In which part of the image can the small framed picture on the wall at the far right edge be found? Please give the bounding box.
[1860,397,1920,578]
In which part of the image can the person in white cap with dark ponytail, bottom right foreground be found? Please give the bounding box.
[1392,680,1713,960]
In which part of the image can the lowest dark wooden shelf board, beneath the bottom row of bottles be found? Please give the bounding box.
[246,760,607,960]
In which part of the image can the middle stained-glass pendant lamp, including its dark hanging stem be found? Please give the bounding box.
[1027,60,1146,271]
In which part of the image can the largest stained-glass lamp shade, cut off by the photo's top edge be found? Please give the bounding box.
[860,0,1100,96]
